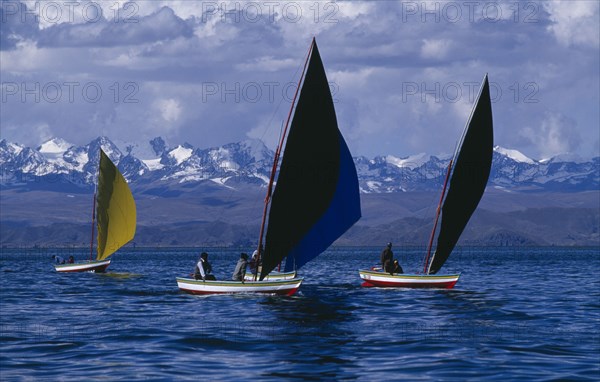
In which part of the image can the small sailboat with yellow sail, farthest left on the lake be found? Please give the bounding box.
[54,148,136,272]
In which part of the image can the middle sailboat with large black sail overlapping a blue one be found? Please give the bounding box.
[177,38,361,295]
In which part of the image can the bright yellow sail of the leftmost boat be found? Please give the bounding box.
[96,149,136,260]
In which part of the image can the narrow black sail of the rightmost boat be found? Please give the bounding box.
[429,76,494,274]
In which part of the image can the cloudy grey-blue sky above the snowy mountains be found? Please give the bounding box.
[0,0,600,159]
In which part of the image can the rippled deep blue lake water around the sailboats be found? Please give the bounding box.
[0,248,600,381]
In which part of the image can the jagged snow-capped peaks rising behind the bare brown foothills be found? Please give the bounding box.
[0,137,600,193]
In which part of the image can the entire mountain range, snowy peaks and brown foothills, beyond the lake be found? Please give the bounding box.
[0,137,600,246]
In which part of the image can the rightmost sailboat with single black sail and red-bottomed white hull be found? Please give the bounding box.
[359,74,494,289]
